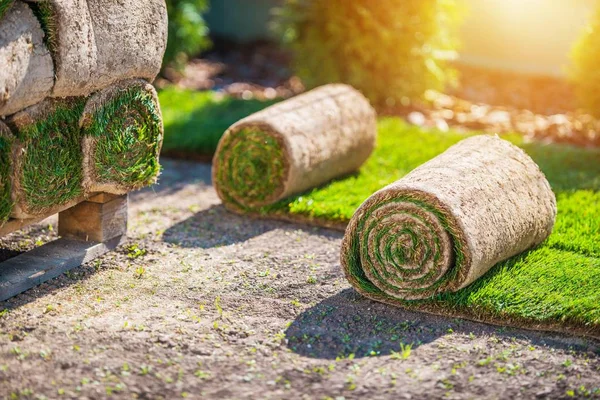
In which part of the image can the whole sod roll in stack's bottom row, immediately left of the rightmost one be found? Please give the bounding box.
[7,98,85,219]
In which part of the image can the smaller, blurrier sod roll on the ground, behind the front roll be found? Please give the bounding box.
[213,84,377,212]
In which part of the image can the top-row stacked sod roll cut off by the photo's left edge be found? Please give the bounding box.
[0,0,54,116]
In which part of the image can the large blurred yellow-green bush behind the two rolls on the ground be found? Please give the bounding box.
[273,0,462,107]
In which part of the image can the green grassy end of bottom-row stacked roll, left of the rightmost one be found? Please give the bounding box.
[15,98,85,212]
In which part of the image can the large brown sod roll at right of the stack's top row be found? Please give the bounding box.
[28,0,167,97]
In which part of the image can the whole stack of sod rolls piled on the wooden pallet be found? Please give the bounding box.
[0,0,167,224]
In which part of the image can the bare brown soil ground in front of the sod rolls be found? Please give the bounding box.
[0,160,600,399]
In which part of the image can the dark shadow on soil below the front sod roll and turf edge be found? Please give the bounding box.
[285,289,600,359]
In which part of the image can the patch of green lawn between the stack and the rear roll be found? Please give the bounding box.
[158,87,275,158]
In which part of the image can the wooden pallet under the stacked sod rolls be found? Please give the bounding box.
[0,193,127,301]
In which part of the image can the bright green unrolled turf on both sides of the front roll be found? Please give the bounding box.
[261,118,600,337]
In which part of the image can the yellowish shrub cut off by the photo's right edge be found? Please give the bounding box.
[569,7,600,118]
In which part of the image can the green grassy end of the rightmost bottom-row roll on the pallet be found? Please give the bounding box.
[85,89,162,188]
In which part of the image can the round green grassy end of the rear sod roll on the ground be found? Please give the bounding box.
[216,127,287,209]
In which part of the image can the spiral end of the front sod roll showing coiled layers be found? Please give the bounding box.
[345,192,466,300]
